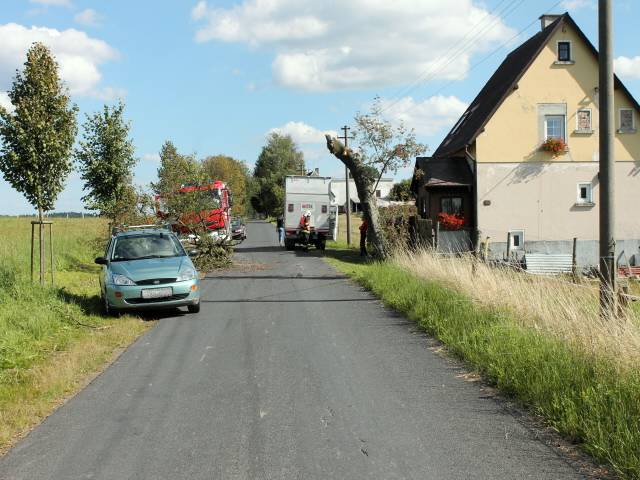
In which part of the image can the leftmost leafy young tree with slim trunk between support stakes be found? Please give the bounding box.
[0,43,78,283]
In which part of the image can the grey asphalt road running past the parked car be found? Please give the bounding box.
[0,223,583,480]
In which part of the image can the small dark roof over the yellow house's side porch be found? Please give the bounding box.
[411,157,473,192]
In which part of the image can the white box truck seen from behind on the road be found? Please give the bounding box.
[284,175,338,250]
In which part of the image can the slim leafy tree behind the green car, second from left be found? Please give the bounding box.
[75,102,137,223]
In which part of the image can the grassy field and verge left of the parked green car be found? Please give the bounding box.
[0,218,150,451]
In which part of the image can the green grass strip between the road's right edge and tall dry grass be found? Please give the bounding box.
[327,244,640,478]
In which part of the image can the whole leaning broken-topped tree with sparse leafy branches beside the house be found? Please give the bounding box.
[325,98,427,259]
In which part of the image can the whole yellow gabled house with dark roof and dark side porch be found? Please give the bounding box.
[413,13,640,265]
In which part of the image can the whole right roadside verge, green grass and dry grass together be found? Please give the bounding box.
[327,245,640,479]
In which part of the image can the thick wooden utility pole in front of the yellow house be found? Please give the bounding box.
[598,0,617,316]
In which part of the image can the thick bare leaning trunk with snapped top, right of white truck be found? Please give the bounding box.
[325,135,388,259]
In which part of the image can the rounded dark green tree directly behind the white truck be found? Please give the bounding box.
[251,133,305,216]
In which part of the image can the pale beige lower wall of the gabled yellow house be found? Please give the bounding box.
[477,161,640,244]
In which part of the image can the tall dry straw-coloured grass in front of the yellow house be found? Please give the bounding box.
[392,250,640,367]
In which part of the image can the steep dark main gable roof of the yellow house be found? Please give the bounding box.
[434,13,640,157]
